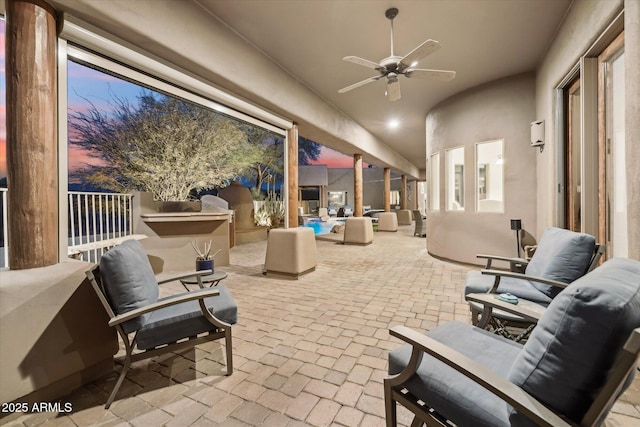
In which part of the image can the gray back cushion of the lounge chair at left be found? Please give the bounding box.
[100,240,159,333]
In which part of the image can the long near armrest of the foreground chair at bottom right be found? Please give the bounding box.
[385,326,571,427]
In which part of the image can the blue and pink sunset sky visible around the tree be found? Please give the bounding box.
[0,20,353,182]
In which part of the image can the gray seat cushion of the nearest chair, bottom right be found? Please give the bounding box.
[389,321,522,427]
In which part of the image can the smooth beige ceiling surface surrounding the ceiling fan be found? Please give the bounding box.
[198,0,571,169]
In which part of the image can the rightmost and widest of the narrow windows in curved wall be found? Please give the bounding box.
[476,140,504,213]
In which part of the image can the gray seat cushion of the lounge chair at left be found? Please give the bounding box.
[137,286,238,350]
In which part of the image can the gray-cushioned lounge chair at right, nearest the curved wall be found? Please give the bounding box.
[464,227,605,341]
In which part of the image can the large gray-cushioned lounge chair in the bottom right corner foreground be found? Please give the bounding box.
[384,258,640,427]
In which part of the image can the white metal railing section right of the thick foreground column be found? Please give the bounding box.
[68,191,133,262]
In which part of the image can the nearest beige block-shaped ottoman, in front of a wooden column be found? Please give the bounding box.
[264,227,318,278]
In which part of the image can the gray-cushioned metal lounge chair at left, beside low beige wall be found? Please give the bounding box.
[86,240,238,409]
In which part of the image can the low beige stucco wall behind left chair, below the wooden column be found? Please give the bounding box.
[0,261,118,402]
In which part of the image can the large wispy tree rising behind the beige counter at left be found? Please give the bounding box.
[69,92,261,201]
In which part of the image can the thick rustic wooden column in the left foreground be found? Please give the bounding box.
[5,0,58,270]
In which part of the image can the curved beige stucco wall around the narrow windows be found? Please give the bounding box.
[426,73,539,263]
